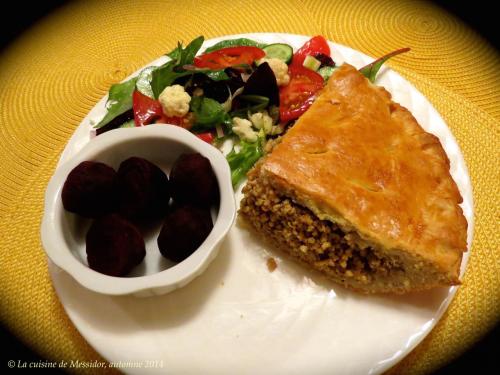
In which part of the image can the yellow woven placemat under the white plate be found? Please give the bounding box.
[0,0,500,374]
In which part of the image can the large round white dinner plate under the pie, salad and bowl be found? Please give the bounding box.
[49,34,473,375]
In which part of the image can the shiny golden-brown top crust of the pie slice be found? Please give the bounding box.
[260,64,467,284]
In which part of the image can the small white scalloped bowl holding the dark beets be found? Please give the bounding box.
[41,124,236,296]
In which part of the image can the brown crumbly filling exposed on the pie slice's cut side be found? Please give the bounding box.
[240,173,403,284]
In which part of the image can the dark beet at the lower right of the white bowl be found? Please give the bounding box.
[158,205,213,262]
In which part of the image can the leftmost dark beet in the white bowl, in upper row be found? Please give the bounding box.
[61,161,116,218]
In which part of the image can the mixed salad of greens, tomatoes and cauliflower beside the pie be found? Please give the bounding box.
[94,36,408,186]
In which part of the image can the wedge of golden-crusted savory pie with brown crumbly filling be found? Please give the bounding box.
[240,64,467,293]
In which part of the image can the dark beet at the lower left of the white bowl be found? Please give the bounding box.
[86,214,146,276]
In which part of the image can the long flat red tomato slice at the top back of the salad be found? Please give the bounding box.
[194,47,266,70]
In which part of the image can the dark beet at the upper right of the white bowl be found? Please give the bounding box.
[170,153,219,207]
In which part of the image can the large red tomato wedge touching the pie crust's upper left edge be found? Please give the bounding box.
[280,65,324,123]
